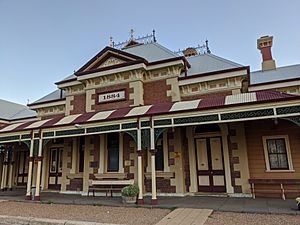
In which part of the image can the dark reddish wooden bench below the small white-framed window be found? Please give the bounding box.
[249,179,300,200]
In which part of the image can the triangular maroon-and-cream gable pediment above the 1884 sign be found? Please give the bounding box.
[75,47,146,75]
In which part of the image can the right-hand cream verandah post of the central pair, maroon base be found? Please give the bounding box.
[150,125,157,205]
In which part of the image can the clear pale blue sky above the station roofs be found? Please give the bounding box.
[0,0,300,104]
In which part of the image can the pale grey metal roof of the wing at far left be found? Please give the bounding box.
[0,99,36,121]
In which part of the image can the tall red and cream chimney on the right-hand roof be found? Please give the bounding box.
[257,36,276,71]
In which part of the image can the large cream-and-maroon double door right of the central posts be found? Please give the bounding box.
[196,137,226,192]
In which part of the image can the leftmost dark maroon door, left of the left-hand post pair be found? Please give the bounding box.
[17,151,29,186]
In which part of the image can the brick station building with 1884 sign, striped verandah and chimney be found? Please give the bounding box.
[0,33,300,204]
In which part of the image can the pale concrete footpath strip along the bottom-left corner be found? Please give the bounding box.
[0,215,119,225]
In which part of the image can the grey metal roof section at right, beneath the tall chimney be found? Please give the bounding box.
[250,64,300,85]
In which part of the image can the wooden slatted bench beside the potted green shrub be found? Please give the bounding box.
[88,180,134,197]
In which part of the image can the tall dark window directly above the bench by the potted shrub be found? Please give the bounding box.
[107,133,119,172]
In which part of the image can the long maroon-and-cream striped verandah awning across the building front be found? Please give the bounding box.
[0,91,300,133]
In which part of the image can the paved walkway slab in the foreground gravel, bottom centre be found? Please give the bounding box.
[156,208,212,225]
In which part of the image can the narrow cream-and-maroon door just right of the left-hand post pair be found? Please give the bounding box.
[48,148,63,190]
